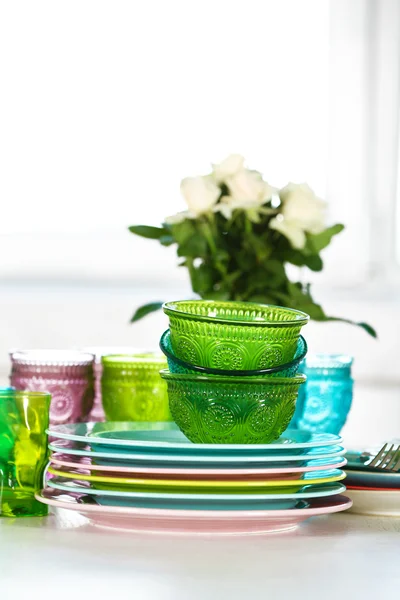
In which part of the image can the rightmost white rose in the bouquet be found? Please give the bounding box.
[269,183,326,249]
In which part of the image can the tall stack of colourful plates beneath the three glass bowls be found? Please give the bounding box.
[38,422,351,534]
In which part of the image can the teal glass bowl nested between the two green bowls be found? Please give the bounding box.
[160,329,308,377]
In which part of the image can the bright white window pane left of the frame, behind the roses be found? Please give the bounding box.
[0,0,329,279]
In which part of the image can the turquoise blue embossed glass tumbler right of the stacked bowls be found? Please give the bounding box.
[289,354,353,434]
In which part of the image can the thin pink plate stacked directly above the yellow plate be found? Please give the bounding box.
[50,453,347,481]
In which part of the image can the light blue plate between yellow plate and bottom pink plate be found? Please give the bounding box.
[47,477,345,510]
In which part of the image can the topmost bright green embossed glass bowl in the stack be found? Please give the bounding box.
[163,300,309,371]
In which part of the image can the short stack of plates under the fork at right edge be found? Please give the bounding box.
[346,448,400,517]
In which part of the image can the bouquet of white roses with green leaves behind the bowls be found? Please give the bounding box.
[129,154,376,337]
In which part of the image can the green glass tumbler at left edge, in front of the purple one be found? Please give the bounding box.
[0,390,51,517]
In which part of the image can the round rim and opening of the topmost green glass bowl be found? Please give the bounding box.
[162,300,310,327]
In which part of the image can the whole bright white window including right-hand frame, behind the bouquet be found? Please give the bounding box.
[0,0,400,285]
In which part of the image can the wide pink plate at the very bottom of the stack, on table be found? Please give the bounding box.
[36,488,353,535]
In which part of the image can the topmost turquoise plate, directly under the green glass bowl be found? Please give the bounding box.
[48,422,342,456]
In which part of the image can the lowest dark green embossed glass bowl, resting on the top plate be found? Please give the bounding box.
[160,370,306,444]
